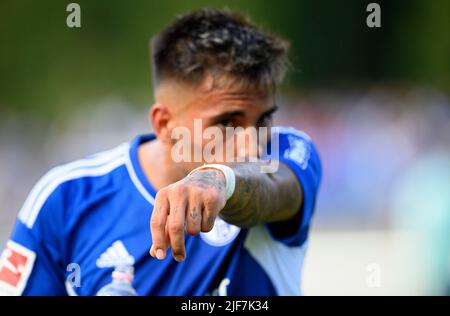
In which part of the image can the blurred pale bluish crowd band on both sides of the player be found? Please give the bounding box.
[0,87,450,293]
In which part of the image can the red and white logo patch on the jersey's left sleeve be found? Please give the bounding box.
[0,240,36,296]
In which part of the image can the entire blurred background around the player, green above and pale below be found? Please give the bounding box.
[0,0,450,295]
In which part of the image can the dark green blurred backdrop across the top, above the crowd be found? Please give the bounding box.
[0,0,450,119]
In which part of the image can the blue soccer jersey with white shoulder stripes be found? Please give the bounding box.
[0,128,321,295]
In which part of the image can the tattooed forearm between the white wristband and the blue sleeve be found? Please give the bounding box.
[219,163,302,227]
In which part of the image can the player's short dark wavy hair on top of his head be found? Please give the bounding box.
[151,9,289,90]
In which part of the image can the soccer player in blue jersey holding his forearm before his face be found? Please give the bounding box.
[0,10,321,295]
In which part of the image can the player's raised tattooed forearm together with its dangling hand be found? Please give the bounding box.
[150,163,302,261]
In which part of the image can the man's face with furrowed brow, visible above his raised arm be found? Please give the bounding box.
[153,80,277,170]
